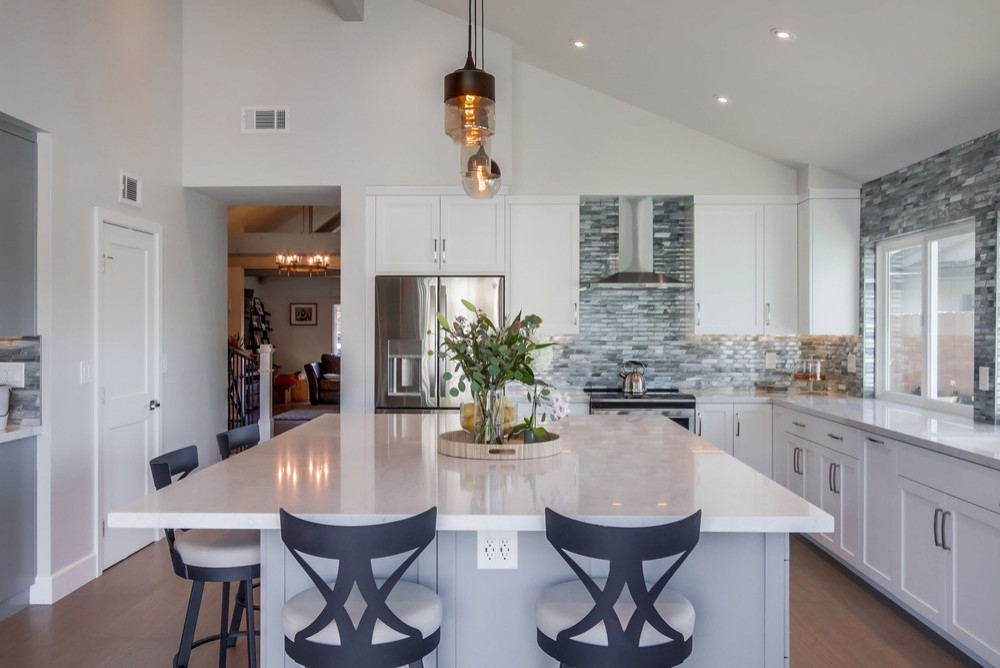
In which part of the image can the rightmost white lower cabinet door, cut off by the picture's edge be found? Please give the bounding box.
[944,498,1000,665]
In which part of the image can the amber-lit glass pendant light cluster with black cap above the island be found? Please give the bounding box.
[444,0,500,199]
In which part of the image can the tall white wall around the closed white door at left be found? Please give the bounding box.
[0,0,226,602]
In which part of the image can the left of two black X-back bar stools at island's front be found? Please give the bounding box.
[281,508,442,668]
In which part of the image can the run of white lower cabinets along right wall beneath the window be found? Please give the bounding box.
[772,407,1000,666]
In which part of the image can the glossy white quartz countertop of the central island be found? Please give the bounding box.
[108,414,833,533]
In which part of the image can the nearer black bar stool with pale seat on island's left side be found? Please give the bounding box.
[149,445,260,668]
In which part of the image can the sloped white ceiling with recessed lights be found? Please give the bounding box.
[420,0,1000,182]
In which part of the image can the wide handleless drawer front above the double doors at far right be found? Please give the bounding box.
[898,443,1000,513]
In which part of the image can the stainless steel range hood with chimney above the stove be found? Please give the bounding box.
[585,197,690,288]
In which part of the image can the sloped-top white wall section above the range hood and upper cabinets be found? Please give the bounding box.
[507,60,796,195]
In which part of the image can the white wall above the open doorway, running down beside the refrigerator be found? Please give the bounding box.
[183,0,514,411]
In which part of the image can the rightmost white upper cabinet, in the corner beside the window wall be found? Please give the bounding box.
[798,190,861,334]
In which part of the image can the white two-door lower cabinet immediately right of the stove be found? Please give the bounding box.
[695,403,773,477]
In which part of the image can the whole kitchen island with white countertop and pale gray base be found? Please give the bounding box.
[109,414,833,667]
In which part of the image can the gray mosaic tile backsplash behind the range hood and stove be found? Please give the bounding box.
[544,197,861,394]
